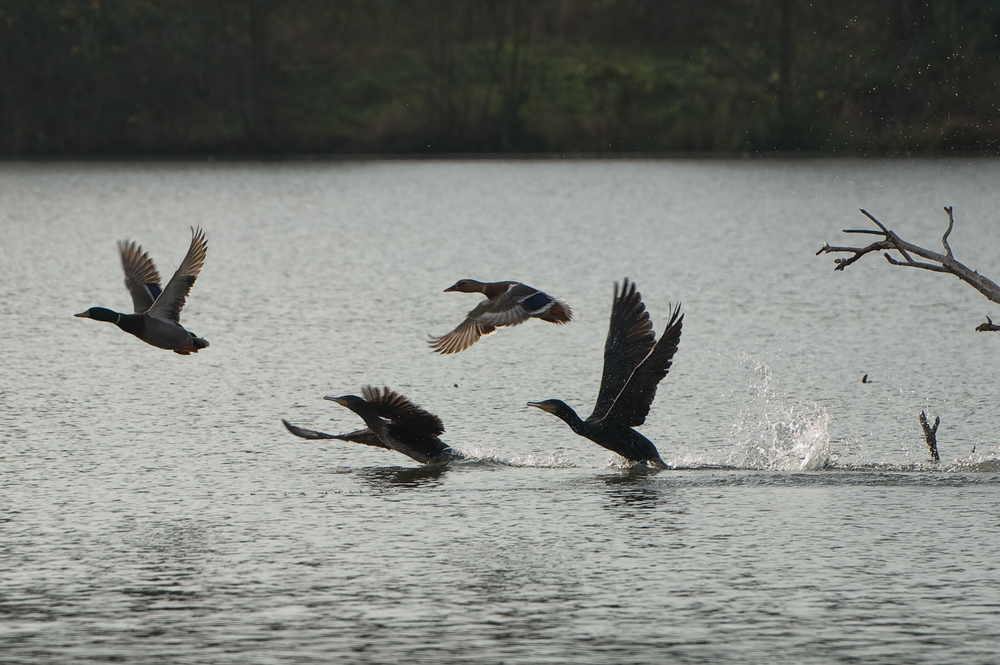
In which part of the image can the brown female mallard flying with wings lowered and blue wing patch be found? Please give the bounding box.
[428,279,573,354]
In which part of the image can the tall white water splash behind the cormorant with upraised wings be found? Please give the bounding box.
[727,356,830,471]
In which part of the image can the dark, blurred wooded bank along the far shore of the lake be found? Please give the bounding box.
[0,0,1000,156]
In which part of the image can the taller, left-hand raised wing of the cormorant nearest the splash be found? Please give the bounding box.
[588,277,656,420]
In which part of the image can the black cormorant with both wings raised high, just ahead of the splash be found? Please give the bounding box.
[528,277,684,469]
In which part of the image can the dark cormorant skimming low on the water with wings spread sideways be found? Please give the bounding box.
[281,386,462,464]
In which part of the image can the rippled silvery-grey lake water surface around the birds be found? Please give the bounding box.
[0,159,1000,664]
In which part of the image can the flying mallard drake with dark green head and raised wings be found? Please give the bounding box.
[75,227,208,356]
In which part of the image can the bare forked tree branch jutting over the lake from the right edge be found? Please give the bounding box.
[816,206,1000,332]
